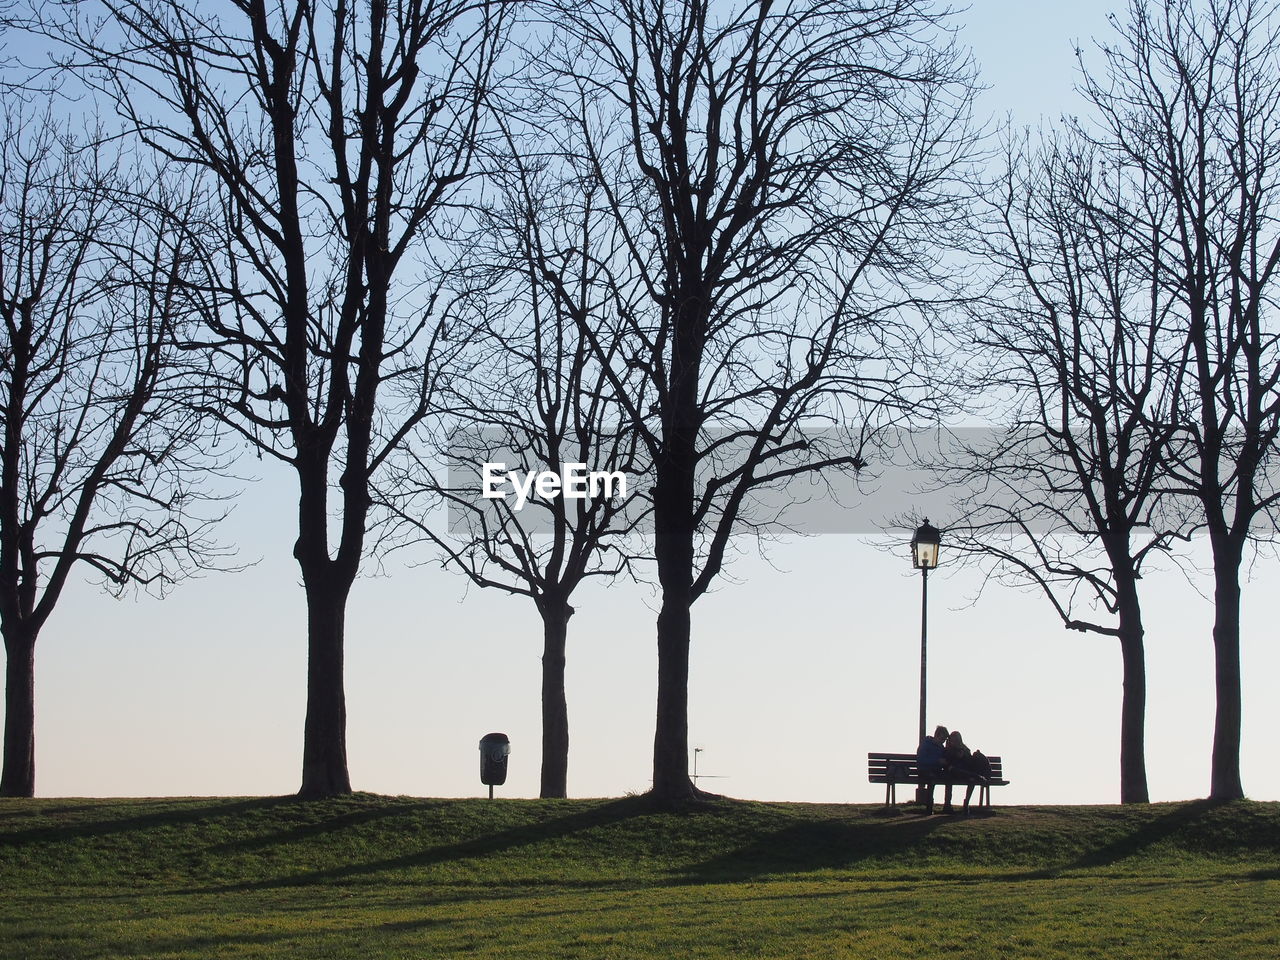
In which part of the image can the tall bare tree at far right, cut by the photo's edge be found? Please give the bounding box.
[1084,0,1280,800]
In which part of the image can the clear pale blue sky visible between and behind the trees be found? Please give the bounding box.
[17,0,1280,803]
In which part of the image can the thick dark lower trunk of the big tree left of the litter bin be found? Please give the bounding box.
[298,576,351,797]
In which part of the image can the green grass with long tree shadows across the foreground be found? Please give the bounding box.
[0,795,1280,960]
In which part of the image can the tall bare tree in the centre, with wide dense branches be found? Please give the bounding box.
[538,0,970,801]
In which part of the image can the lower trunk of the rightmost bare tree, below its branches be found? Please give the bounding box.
[1210,563,1244,800]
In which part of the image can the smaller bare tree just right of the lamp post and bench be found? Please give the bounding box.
[942,129,1189,803]
